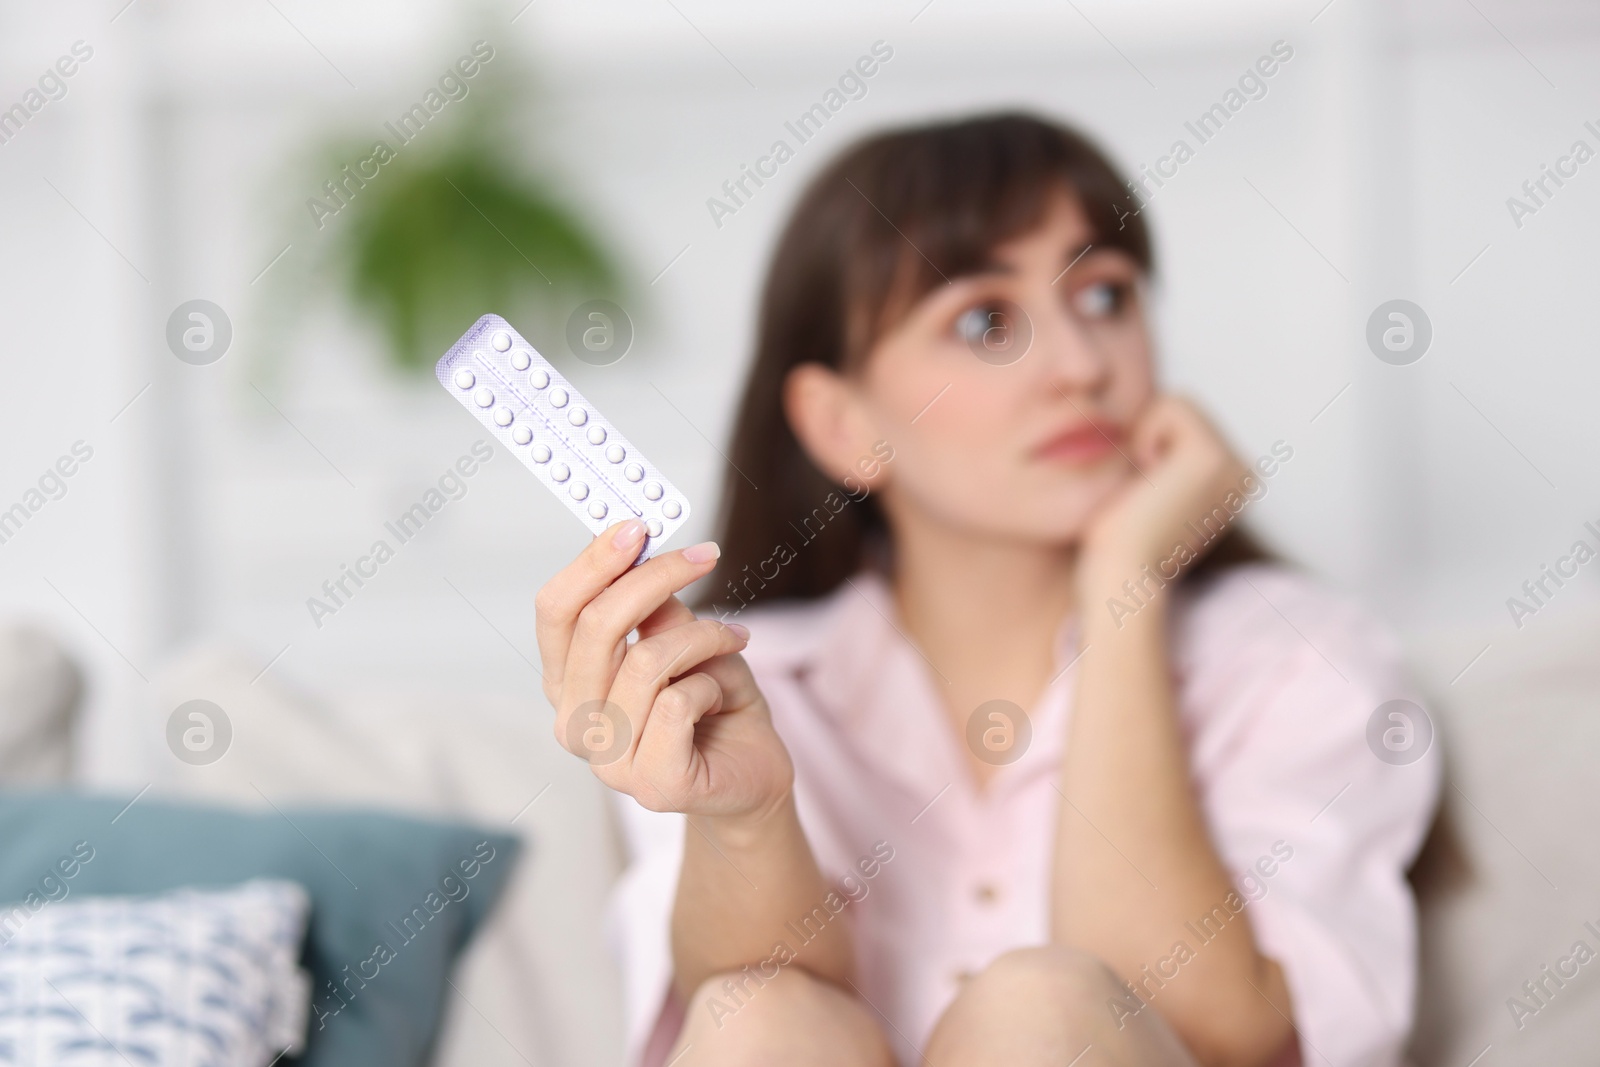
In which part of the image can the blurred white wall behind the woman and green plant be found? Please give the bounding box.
[9,0,1600,758]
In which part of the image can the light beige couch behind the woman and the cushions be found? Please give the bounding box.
[0,608,1600,1067]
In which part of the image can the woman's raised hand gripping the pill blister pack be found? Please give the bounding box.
[534,520,794,816]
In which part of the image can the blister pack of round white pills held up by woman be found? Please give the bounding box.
[434,315,690,565]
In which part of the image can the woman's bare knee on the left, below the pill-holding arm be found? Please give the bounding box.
[669,968,893,1067]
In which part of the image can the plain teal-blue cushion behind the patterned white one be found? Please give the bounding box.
[0,792,518,1067]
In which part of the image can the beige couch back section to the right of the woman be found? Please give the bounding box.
[1413,600,1600,1067]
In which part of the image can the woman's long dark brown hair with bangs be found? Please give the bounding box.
[696,114,1269,616]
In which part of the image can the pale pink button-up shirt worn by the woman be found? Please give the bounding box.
[610,565,1440,1067]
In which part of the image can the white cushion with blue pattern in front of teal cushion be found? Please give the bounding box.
[0,880,310,1067]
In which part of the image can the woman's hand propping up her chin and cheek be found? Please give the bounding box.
[1078,394,1250,587]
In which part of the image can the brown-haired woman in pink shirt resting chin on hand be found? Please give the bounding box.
[538,115,1438,1067]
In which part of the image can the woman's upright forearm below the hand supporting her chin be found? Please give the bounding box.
[1051,565,1290,1064]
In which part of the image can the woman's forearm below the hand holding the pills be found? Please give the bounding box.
[672,792,854,1003]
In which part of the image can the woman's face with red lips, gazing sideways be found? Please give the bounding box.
[854,192,1154,544]
